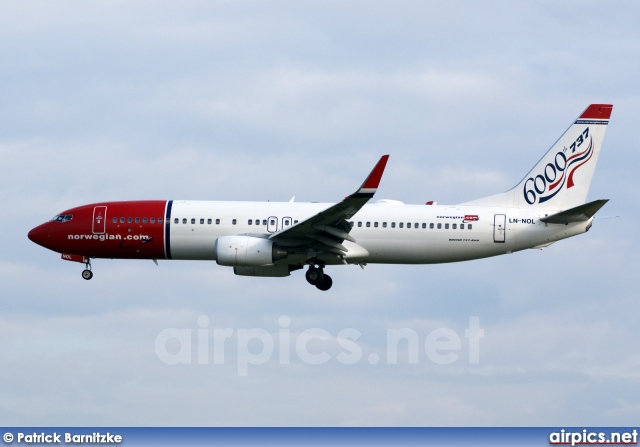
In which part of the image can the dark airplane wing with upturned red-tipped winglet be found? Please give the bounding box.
[269,155,389,259]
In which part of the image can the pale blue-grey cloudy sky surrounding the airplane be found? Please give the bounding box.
[0,0,640,426]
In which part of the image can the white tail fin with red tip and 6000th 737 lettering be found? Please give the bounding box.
[463,104,613,210]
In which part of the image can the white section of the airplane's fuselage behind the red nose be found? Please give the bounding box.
[168,200,592,264]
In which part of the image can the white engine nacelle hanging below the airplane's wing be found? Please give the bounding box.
[215,236,288,267]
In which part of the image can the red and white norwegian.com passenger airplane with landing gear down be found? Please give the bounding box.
[28,104,613,291]
